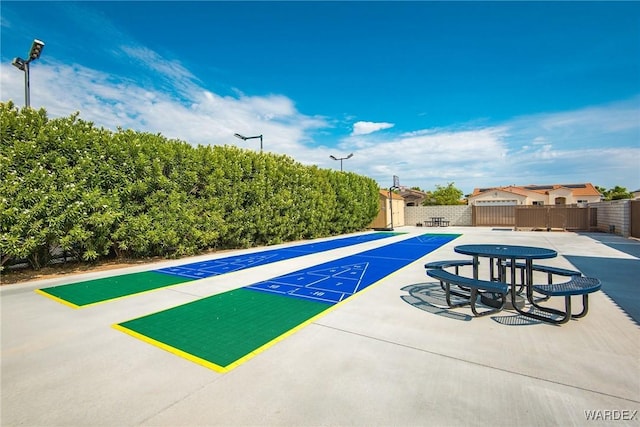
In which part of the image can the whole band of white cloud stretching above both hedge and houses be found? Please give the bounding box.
[0,55,640,193]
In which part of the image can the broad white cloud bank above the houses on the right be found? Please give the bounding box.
[332,98,640,193]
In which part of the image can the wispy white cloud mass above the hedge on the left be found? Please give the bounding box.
[0,61,327,154]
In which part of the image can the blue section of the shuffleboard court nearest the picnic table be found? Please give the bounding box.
[247,234,460,304]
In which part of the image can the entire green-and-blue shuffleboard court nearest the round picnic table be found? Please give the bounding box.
[114,234,459,372]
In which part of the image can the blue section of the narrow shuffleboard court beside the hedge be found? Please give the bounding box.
[154,232,404,279]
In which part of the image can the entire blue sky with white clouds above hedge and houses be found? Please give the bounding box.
[0,0,640,194]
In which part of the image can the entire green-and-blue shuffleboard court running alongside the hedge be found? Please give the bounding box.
[36,232,402,308]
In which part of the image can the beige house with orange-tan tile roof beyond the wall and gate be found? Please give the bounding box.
[468,183,602,206]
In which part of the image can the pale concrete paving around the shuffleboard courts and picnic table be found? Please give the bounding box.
[0,227,640,426]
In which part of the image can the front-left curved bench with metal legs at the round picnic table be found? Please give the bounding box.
[427,268,509,316]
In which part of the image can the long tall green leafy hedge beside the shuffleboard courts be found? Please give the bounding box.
[0,102,378,269]
